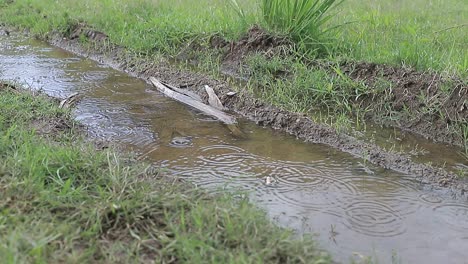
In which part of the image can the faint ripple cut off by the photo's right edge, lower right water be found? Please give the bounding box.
[434,203,468,232]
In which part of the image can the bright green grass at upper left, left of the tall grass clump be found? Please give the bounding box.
[0,0,256,56]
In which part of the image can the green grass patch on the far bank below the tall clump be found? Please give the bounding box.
[247,55,372,112]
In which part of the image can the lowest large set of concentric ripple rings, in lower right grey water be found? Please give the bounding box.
[343,201,406,237]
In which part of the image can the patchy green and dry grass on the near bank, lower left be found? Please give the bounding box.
[0,82,330,263]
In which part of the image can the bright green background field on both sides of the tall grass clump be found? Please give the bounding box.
[0,0,468,77]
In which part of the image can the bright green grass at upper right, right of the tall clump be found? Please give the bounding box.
[334,0,468,75]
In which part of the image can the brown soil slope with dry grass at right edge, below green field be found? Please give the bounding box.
[343,63,468,146]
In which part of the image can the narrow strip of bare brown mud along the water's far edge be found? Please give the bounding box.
[4,26,468,199]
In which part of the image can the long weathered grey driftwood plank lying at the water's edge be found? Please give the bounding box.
[150,77,237,125]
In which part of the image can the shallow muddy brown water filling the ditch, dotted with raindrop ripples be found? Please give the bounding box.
[0,36,468,263]
